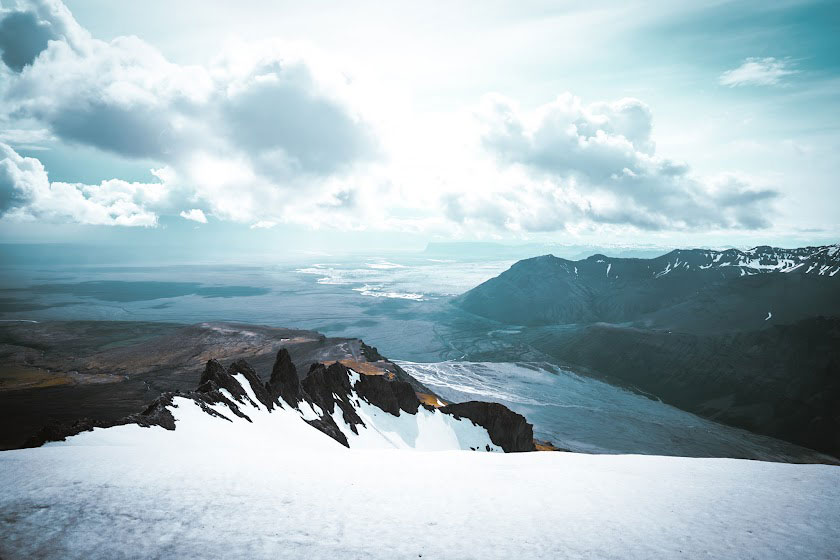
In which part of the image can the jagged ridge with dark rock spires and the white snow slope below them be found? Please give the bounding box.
[36,349,535,452]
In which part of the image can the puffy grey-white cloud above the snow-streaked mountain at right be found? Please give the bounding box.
[478,94,778,231]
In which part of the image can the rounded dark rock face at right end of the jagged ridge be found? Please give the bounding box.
[440,401,536,453]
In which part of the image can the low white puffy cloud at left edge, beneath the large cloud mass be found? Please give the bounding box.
[0,143,165,226]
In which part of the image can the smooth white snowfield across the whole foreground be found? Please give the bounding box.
[0,426,840,560]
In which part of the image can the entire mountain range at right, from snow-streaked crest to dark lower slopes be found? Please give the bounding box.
[454,245,840,455]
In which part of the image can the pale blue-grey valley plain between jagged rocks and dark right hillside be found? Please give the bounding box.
[400,362,826,462]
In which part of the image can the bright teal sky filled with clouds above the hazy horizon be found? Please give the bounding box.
[0,0,840,255]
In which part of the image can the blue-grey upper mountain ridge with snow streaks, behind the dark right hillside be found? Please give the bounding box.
[455,245,840,327]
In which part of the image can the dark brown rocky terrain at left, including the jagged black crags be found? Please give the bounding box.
[0,322,535,451]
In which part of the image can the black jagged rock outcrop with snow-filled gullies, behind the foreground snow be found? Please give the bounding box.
[30,350,548,452]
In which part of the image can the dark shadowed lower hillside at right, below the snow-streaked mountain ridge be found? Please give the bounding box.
[522,317,840,456]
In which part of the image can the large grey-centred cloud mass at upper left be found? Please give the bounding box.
[0,0,379,222]
